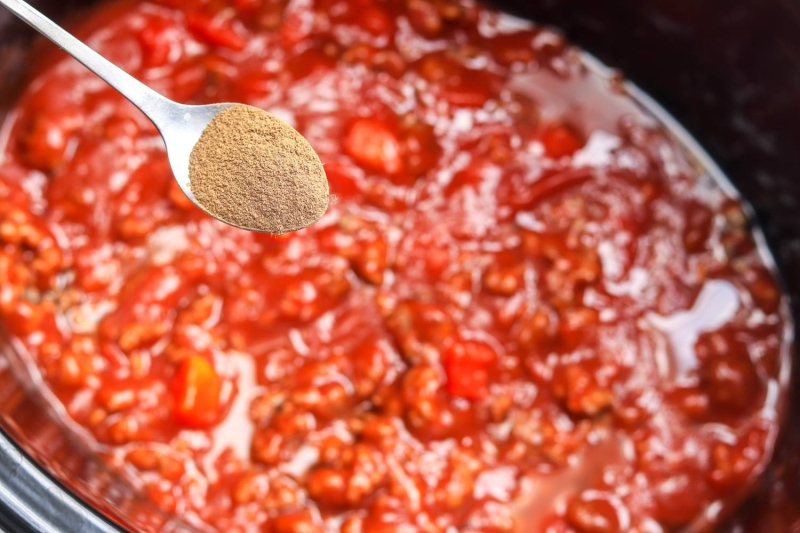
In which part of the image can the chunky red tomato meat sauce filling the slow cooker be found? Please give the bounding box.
[0,0,790,533]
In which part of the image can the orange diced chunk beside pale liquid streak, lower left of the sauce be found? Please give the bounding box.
[172,355,222,428]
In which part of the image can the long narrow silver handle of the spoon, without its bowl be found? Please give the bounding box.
[0,0,173,121]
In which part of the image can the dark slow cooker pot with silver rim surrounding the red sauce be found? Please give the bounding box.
[0,0,800,532]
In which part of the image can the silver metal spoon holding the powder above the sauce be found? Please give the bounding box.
[0,0,306,229]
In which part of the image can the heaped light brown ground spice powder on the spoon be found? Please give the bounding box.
[189,105,329,234]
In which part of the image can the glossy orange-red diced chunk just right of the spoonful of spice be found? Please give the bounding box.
[344,118,403,174]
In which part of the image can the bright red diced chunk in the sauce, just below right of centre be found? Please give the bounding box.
[443,341,497,400]
